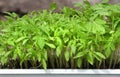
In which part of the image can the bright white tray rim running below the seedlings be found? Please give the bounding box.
[0,69,120,75]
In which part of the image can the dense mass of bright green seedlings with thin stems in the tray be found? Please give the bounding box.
[0,1,120,69]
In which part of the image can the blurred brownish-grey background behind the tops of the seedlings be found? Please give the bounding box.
[0,0,120,19]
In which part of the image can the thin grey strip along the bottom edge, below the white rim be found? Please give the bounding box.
[0,74,120,77]
